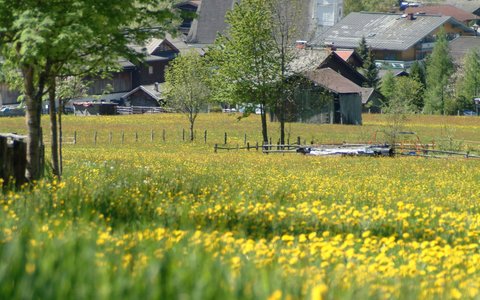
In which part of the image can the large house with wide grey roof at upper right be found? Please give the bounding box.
[311,12,474,68]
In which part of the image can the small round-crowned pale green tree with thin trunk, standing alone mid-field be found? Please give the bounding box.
[164,51,211,141]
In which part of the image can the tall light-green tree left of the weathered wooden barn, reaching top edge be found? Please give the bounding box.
[211,0,281,143]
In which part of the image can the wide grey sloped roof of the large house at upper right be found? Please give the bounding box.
[312,12,473,51]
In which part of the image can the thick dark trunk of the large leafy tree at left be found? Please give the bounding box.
[22,67,43,183]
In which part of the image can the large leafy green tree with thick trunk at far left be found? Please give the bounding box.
[0,0,174,181]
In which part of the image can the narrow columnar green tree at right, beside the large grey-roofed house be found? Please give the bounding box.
[424,29,454,114]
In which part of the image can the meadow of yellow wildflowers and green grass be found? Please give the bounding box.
[0,114,480,299]
